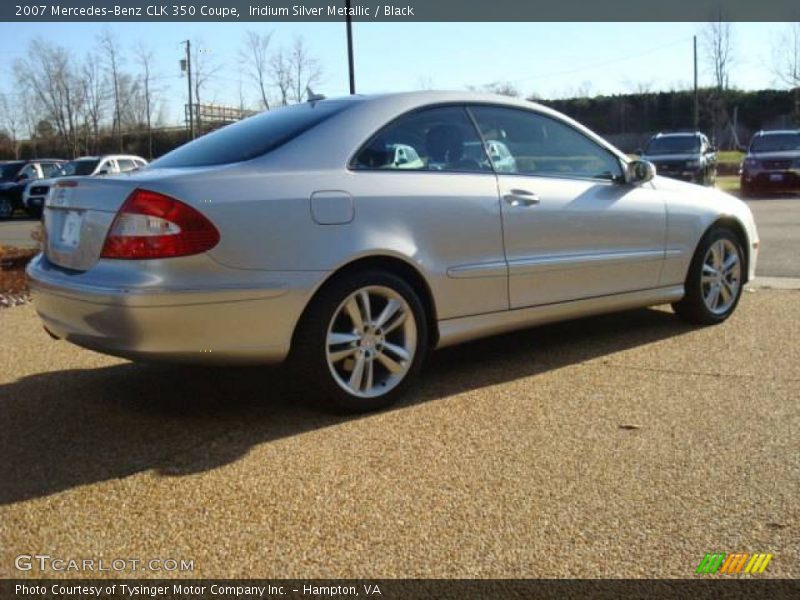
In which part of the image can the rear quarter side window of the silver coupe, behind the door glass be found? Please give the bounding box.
[351,106,492,172]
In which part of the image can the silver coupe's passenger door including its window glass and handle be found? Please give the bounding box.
[470,105,666,308]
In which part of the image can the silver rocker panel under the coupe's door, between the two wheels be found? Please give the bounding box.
[436,284,684,348]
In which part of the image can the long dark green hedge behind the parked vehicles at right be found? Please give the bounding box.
[537,88,800,151]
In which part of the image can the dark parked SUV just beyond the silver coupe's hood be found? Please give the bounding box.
[639,131,717,185]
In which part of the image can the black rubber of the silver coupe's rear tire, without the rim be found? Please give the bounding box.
[290,271,429,413]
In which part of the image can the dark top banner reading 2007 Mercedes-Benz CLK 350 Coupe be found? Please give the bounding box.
[0,0,800,22]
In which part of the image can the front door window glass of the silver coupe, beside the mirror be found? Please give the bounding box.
[470,106,622,179]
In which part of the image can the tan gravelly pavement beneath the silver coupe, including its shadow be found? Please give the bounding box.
[0,290,800,578]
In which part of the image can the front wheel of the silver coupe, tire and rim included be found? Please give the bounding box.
[672,226,746,325]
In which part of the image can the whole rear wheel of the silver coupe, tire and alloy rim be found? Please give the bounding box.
[290,270,429,413]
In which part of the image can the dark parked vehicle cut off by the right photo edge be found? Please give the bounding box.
[739,129,800,196]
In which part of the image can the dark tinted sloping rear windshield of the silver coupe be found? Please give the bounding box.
[150,100,353,168]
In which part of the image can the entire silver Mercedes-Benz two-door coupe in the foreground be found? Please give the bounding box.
[28,92,758,411]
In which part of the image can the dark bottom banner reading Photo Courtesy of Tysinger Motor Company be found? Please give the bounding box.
[0,577,800,600]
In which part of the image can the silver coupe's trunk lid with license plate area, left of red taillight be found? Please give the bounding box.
[43,177,139,271]
